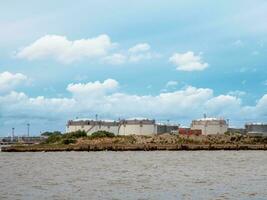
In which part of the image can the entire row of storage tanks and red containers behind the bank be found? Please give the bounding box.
[66,116,267,136]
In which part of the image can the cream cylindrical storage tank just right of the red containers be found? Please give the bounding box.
[191,118,228,135]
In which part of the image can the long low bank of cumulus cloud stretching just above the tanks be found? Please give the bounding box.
[0,79,267,134]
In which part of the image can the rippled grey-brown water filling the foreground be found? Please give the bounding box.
[0,151,267,200]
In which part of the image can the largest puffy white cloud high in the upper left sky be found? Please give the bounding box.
[17,35,114,63]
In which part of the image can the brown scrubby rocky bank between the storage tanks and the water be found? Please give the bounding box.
[2,134,267,152]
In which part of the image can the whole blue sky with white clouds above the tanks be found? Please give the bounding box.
[0,0,267,136]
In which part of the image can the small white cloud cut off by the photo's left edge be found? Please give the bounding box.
[0,71,27,93]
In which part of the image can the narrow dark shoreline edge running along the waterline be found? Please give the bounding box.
[1,144,267,152]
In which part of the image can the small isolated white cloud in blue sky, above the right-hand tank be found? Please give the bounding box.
[169,51,208,71]
